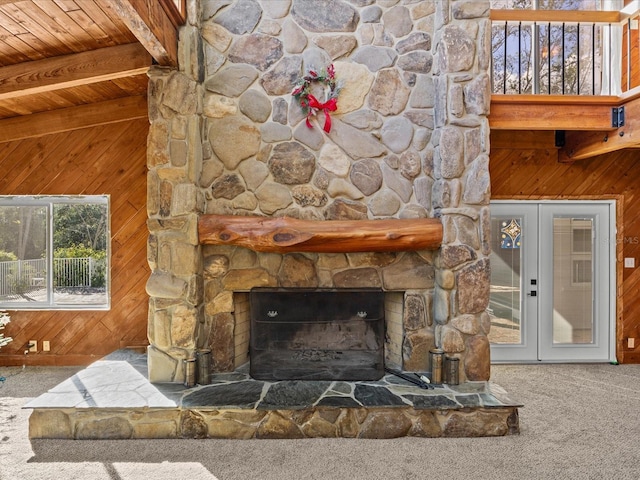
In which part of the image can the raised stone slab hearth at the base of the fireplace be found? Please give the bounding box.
[24,350,521,439]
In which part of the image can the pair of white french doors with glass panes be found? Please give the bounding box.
[489,201,615,363]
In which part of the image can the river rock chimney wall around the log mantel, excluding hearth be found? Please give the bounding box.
[147,0,490,381]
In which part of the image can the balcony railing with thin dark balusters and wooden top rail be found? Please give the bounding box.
[491,0,640,96]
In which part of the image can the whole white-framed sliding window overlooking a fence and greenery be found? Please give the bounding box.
[0,196,110,310]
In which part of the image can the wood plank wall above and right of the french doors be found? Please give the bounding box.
[489,142,640,363]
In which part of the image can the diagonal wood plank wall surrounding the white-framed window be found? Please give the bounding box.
[0,119,150,366]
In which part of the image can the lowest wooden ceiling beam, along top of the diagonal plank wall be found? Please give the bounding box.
[0,96,148,142]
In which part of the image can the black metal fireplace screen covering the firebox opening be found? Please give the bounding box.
[250,288,385,381]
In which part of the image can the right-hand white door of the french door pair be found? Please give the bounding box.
[538,202,615,362]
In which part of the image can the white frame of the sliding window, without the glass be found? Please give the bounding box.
[0,194,111,311]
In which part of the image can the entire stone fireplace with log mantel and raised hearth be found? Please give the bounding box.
[22,0,519,439]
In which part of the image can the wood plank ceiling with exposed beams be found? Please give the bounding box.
[0,0,185,142]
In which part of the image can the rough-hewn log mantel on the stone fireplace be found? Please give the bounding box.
[198,215,442,253]
